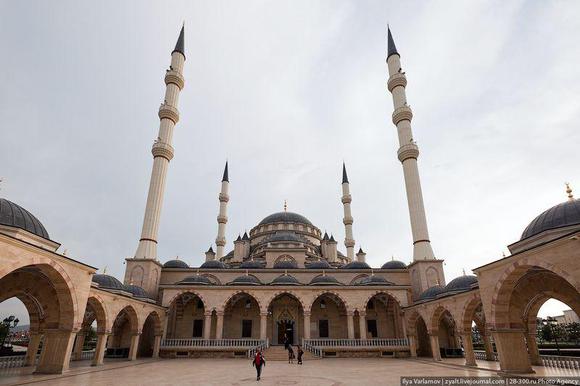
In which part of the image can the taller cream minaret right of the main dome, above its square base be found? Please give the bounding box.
[387,29,435,261]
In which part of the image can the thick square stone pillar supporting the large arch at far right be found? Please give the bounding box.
[492,329,534,374]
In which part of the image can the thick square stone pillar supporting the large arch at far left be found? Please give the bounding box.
[35,330,75,374]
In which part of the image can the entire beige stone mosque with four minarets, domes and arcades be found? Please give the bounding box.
[0,24,580,373]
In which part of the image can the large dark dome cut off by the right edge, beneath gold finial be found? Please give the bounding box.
[520,199,580,240]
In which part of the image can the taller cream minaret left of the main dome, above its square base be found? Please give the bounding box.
[135,26,185,260]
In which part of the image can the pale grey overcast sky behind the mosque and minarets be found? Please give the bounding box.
[0,0,580,322]
